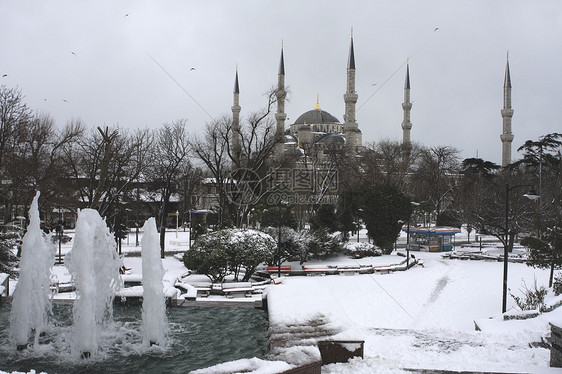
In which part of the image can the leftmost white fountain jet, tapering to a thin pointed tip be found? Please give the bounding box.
[9,191,55,350]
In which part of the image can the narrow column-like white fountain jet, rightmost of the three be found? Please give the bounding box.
[142,218,168,346]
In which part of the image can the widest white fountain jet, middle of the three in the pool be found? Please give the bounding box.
[65,209,122,358]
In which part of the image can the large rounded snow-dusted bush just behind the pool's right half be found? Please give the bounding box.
[183,229,277,282]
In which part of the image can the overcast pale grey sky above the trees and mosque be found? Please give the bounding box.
[0,0,562,164]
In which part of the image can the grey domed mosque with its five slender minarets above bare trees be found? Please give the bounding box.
[232,34,513,167]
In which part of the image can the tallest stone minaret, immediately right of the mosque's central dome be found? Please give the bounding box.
[343,30,362,151]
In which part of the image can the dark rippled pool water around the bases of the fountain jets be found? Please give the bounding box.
[0,303,269,374]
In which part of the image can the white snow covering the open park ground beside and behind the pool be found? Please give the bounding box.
[4,226,562,373]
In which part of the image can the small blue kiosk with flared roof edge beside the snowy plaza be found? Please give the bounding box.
[402,227,461,252]
